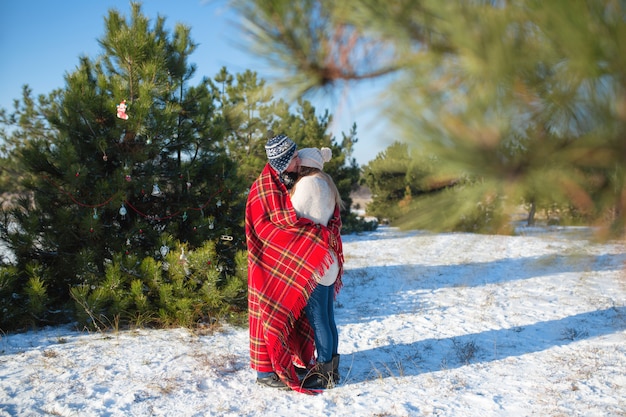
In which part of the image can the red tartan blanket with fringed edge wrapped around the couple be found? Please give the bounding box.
[245,164,343,393]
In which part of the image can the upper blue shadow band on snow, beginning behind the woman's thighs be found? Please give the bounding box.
[336,249,626,325]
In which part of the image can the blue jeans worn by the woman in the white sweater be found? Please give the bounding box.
[304,284,339,362]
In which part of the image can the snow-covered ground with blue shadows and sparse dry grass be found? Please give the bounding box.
[0,227,626,417]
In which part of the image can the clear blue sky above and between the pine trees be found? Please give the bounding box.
[0,0,386,164]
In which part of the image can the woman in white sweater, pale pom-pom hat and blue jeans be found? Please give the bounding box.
[291,148,343,388]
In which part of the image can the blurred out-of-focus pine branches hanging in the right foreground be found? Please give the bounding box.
[232,0,626,233]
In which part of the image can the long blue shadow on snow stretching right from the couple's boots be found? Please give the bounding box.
[341,307,626,384]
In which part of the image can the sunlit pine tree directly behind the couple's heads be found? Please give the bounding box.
[214,69,360,232]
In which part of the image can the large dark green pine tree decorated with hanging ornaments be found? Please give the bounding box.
[2,3,245,327]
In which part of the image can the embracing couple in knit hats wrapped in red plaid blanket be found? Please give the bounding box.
[245,135,343,393]
